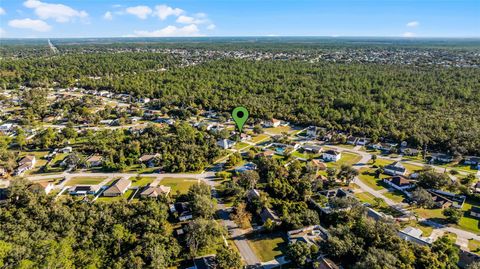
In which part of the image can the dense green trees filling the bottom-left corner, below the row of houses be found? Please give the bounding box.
[0,180,180,268]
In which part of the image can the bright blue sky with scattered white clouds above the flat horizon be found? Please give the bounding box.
[0,0,480,37]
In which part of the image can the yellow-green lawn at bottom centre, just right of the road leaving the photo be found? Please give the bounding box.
[247,233,288,262]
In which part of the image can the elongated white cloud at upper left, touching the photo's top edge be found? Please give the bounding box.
[23,0,88,22]
